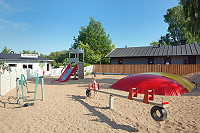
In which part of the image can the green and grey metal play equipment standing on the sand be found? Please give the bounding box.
[16,74,44,104]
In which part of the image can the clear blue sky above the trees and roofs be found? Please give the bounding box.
[0,0,178,54]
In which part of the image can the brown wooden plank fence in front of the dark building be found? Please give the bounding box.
[93,64,200,75]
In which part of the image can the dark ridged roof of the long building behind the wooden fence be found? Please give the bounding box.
[106,44,200,57]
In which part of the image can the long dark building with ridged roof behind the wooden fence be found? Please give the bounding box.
[106,44,200,64]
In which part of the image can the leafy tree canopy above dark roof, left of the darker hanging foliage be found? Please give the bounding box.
[158,0,200,45]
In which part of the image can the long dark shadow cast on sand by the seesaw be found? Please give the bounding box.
[67,95,139,132]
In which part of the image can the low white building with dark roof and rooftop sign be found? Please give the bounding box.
[0,53,53,78]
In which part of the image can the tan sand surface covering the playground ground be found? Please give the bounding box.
[0,75,200,133]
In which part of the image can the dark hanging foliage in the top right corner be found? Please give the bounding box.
[180,0,200,38]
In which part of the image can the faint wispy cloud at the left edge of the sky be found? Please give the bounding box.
[0,19,28,31]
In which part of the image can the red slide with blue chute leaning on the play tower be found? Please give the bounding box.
[51,64,77,83]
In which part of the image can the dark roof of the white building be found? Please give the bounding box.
[0,53,53,61]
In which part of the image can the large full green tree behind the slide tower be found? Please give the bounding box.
[72,17,115,64]
